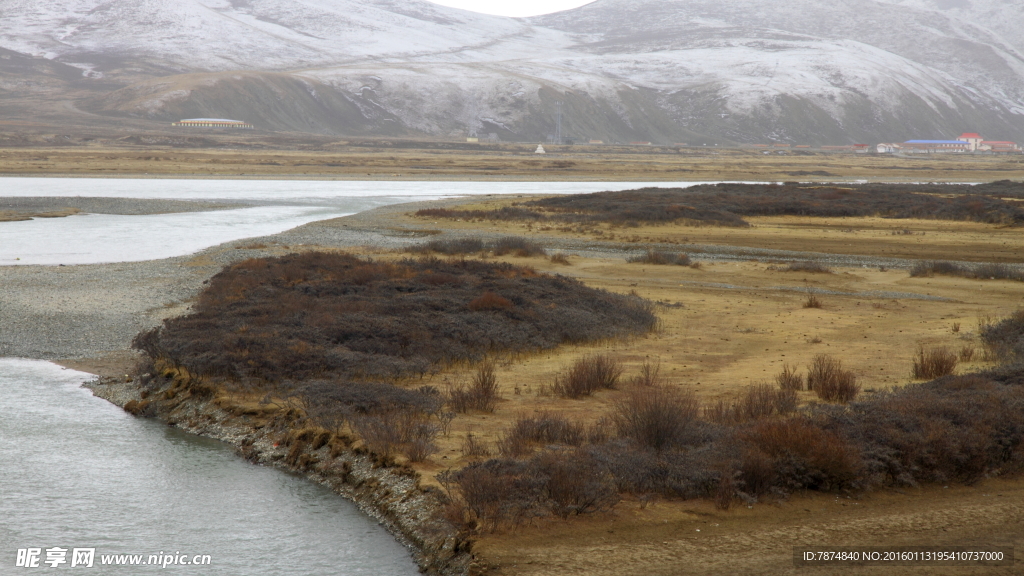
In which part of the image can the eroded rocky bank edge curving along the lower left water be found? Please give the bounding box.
[84,377,475,576]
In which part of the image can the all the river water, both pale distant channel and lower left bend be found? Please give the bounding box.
[0,178,692,576]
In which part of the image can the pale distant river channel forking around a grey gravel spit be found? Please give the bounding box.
[0,178,712,265]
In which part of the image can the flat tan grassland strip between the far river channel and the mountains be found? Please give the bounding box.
[0,141,1024,181]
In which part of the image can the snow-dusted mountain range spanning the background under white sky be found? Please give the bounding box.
[0,0,1024,143]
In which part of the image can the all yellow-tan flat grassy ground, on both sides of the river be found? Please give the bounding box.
[8,142,1024,575]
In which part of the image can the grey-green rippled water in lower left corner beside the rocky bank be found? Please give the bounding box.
[0,358,418,575]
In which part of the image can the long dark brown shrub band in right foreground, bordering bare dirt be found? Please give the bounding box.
[454,365,1024,527]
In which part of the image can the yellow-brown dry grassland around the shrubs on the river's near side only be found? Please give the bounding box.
[362,205,1024,575]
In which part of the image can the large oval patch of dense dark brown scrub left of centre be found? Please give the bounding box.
[134,252,656,384]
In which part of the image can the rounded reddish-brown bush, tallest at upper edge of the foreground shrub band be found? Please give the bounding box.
[611,386,699,450]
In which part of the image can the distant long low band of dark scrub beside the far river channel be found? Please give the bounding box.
[417,180,1024,227]
